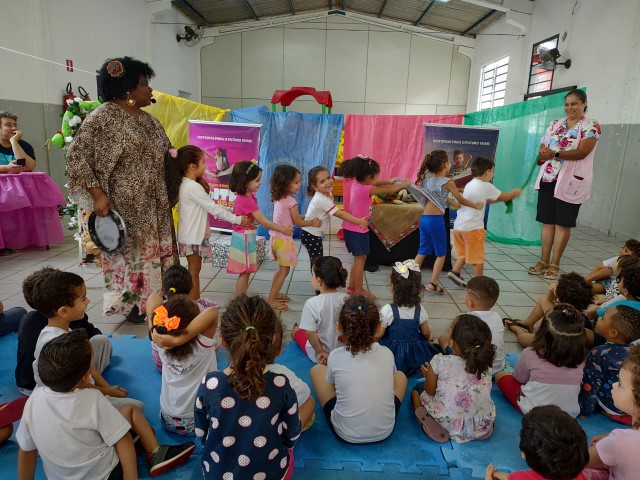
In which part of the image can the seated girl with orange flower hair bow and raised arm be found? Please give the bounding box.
[147,295,218,436]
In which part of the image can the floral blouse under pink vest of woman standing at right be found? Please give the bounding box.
[542,116,600,182]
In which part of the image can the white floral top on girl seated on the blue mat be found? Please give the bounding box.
[420,354,496,443]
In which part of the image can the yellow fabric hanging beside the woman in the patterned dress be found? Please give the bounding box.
[143,90,230,148]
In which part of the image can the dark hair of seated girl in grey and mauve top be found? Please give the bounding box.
[531,303,587,368]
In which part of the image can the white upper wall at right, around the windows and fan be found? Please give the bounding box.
[467,0,640,124]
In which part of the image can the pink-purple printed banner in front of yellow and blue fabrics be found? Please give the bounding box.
[189,120,260,231]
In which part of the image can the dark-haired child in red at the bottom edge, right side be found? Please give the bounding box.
[485,405,589,480]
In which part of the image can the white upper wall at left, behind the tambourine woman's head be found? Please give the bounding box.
[0,0,200,105]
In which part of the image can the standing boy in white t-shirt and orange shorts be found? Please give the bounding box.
[447,157,522,287]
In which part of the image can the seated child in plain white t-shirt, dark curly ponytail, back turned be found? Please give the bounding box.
[311,295,407,443]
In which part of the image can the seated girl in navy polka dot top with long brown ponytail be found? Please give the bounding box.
[194,295,301,480]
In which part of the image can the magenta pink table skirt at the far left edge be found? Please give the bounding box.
[0,172,66,249]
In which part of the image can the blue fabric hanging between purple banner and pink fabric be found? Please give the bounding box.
[231,106,344,237]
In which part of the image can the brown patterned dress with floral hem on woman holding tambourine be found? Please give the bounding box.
[67,102,177,315]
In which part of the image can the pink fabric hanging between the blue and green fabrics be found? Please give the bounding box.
[344,115,464,180]
